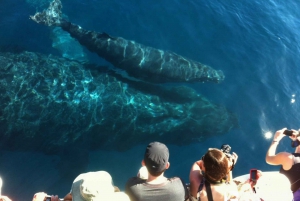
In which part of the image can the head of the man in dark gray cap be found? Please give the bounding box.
[143,142,169,176]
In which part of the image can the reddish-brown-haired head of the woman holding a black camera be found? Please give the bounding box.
[202,149,229,182]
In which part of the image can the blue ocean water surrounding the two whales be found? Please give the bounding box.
[0,0,300,200]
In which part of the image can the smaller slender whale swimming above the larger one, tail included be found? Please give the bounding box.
[30,0,225,83]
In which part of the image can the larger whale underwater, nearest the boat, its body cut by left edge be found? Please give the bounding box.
[0,51,238,154]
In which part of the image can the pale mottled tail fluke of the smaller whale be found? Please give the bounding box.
[30,0,63,26]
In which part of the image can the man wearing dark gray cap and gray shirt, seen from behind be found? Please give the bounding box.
[125,142,189,201]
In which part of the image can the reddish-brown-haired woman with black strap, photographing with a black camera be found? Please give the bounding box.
[189,145,238,201]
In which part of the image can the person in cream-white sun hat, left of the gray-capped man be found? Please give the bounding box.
[71,171,129,201]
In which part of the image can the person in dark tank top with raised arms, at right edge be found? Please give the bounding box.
[266,128,300,201]
